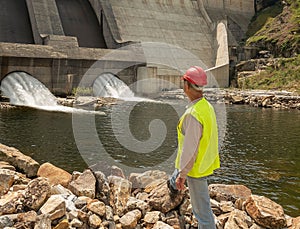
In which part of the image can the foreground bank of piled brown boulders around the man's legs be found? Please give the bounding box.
[0,144,300,229]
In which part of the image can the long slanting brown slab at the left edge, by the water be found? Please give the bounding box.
[0,143,40,177]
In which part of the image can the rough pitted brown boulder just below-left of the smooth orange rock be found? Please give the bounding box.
[24,177,51,211]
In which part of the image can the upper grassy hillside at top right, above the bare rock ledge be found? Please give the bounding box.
[246,0,300,57]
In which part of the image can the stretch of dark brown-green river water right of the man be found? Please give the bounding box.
[213,106,300,215]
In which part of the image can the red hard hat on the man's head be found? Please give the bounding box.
[182,66,207,86]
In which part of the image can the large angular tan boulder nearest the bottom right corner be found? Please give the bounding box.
[245,195,287,229]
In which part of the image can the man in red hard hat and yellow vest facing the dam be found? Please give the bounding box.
[168,66,220,229]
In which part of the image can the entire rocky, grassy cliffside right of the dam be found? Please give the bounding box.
[233,0,300,94]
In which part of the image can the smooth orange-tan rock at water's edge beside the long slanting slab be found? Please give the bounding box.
[37,162,72,187]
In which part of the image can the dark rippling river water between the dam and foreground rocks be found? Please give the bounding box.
[0,101,300,216]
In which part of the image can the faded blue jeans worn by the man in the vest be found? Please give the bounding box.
[170,169,216,229]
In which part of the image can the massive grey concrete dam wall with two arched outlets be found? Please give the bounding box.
[0,0,255,95]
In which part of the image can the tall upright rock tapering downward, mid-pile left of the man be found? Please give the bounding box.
[108,176,131,216]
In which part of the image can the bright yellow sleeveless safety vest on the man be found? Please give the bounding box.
[175,98,220,178]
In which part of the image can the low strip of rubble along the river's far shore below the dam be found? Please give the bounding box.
[0,88,300,110]
